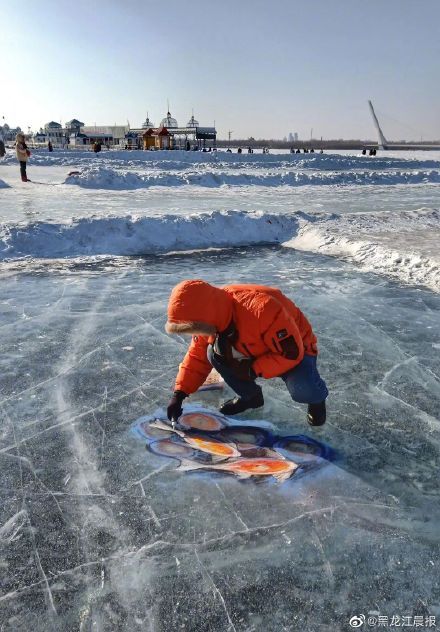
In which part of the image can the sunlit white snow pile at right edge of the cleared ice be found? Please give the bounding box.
[283,209,440,292]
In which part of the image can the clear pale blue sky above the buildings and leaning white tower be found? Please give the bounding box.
[0,0,440,140]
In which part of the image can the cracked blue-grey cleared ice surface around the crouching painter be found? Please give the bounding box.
[0,247,440,632]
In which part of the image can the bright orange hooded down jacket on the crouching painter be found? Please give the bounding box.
[168,280,317,395]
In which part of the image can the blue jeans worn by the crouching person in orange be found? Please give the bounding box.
[207,345,328,404]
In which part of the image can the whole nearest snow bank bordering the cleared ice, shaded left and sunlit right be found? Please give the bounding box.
[0,209,440,292]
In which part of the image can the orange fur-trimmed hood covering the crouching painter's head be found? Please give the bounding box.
[168,279,232,331]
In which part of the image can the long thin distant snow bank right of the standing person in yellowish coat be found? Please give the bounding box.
[64,165,440,190]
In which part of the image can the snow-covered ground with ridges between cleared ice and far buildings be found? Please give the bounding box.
[0,151,440,291]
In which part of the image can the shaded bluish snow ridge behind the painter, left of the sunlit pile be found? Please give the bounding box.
[0,211,306,259]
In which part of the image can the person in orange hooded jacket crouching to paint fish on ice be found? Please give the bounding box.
[165,279,328,426]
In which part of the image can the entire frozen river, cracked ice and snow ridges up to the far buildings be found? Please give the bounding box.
[0,152,440,632]
